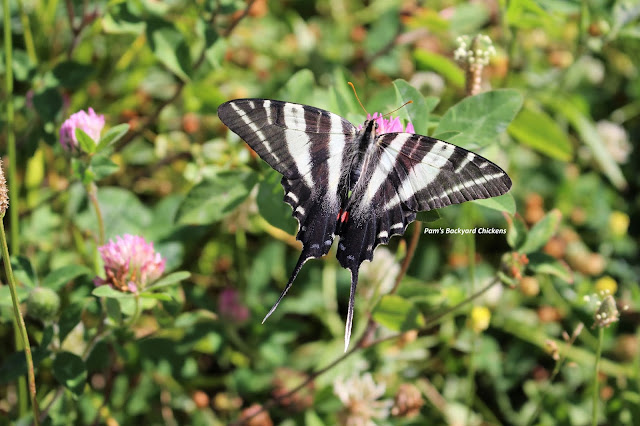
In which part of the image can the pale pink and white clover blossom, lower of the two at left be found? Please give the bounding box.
[93,234,166,293]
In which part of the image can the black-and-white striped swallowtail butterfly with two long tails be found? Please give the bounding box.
[218,99,511,351]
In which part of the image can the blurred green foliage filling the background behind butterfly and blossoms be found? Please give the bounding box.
[0,0,640,425]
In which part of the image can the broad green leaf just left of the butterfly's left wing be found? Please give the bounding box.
[176,170,258,225]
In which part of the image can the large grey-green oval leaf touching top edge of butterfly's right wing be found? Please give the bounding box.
[434,89,522,149]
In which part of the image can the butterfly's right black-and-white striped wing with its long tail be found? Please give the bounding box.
[337,133,511,344]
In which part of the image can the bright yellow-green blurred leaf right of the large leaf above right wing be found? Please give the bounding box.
[508,106,573,161]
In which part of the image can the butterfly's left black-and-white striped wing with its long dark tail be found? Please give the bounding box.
[218,99,357,319]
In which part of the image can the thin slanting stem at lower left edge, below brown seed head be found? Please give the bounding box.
[0,220,40,425]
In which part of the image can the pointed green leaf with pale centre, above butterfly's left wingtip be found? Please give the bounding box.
[147,19,191,81]
